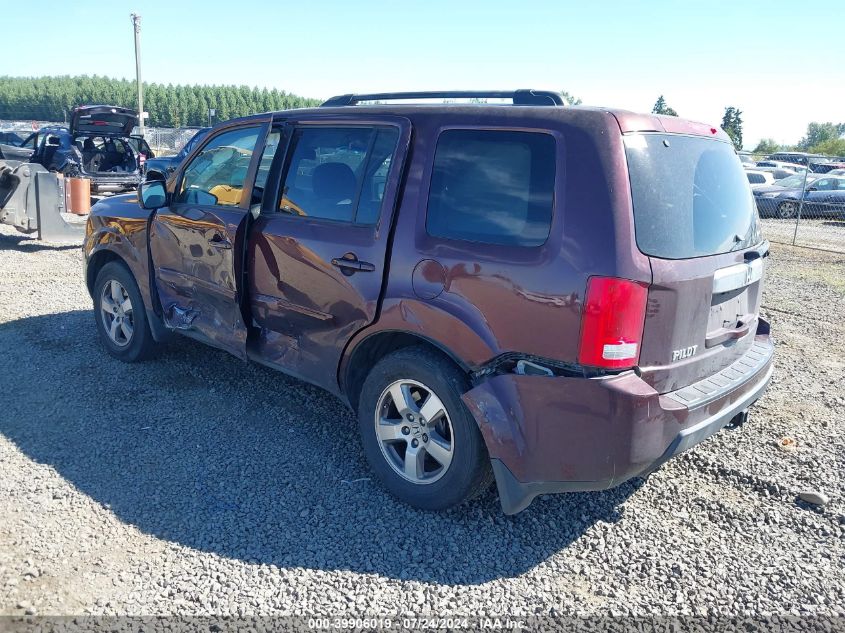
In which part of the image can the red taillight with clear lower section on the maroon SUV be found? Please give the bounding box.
[578,277,648,369]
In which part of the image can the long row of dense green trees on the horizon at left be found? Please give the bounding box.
[0,75,320,127]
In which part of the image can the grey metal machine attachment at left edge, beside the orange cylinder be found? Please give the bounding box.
[0,162,85,244]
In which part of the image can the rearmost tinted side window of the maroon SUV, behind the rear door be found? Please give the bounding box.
[426,130,555,246]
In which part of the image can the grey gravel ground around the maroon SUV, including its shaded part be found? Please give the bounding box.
[0,222,845,616]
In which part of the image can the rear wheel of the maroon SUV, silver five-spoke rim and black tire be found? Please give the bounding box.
[358,347,493,510]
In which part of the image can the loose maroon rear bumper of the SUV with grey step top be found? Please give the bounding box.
[464,322,774,514]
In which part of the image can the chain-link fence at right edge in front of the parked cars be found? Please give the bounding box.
[740,152,845,253]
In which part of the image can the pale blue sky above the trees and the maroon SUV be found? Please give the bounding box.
[0,0,845,146]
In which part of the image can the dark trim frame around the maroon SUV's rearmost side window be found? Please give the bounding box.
[417,124,566,248]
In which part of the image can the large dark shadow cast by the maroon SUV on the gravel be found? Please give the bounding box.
[0,311,638,584]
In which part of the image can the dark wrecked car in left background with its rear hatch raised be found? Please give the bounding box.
[29,106,144,193]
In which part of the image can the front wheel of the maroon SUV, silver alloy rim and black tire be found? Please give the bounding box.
[94,262,155,363]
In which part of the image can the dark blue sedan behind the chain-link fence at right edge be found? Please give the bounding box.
[752,174,845,218]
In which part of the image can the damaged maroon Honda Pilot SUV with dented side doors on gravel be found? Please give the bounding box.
[84,91,773,513]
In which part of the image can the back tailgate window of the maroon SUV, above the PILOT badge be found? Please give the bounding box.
[625,134,760,259]
